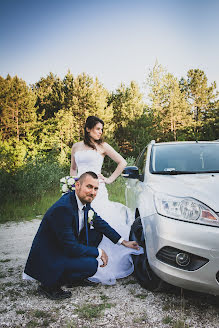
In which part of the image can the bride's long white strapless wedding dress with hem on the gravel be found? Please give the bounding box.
[75,149,143,285]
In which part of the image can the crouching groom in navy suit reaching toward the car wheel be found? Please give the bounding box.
[24,172,139,299]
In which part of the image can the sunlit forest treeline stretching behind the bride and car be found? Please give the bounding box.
[0,63,219,172]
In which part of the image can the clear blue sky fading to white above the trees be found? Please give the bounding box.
[0,0,219,91]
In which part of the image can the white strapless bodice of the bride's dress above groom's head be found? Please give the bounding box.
[75,149,104,176]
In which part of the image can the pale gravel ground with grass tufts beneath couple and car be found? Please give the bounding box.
[0,219,219,328]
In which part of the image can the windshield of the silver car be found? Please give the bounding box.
[150,142,219,174]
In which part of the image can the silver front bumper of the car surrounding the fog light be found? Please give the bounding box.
[142,214,219,295]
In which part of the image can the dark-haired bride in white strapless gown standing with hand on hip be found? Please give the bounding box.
[70,116,142,285]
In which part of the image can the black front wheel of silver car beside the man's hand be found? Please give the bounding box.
[129,217,165,291]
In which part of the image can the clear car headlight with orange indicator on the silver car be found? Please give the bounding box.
[154,193,219,227]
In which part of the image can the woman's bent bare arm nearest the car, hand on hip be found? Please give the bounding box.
[101,142,127,184]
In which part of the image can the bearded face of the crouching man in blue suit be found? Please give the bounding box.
[75,175,99,204]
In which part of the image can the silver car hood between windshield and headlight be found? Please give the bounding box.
[148,173,219,212]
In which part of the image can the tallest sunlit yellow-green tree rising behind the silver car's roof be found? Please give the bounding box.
[148,63,192,141]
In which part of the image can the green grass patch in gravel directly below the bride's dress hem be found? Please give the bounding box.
[75,303,115,320]
